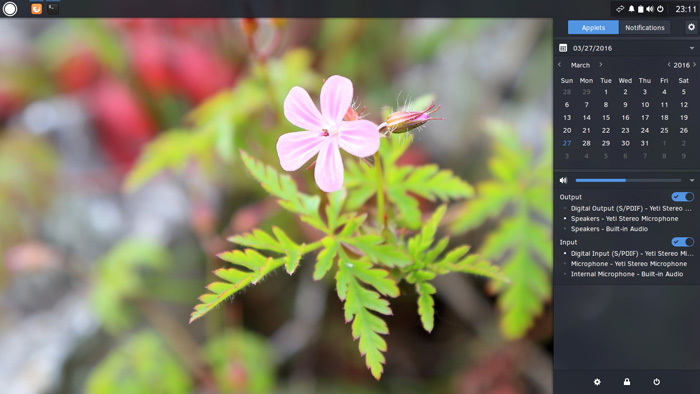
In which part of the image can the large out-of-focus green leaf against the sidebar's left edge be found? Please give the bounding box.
[451,123,552,338]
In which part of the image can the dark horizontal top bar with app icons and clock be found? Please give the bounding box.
[0,0,684,19]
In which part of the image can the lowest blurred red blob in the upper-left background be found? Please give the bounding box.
[87,77,157,170]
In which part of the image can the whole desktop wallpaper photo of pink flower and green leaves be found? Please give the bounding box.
[0,19,552,394]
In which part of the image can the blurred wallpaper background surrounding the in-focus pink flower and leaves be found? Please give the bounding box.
[0,19,552,394]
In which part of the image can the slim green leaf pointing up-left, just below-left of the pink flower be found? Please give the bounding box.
[240,150,328,232]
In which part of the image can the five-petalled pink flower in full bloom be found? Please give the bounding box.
[277,75,379,193]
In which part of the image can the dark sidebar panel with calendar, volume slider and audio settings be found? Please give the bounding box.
[553,13,700,394]
